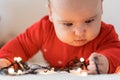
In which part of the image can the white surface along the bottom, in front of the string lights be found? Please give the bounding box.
[0,73,120,80]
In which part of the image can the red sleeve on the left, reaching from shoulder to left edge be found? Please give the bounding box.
[0,17,48,62]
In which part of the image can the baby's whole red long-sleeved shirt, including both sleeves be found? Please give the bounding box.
[0,16,120,73]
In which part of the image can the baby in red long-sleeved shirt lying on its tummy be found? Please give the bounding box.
[0,0,120,74]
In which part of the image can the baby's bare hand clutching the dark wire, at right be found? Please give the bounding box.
[87,53,109,74]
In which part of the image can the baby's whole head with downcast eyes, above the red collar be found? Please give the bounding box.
[49,0,102,46]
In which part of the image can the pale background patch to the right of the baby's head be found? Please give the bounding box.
[103,0,120,35]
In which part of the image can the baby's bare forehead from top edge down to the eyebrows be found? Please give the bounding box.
[50,0,101,19]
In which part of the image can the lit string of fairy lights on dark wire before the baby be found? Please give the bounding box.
[0,57,100,76]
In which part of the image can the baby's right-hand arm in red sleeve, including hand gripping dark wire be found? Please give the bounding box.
[88,24,120,73]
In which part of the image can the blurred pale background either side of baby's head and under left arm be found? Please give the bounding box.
[0,0,120,63]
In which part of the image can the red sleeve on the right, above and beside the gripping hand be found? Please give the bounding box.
[98,22,120,73]
